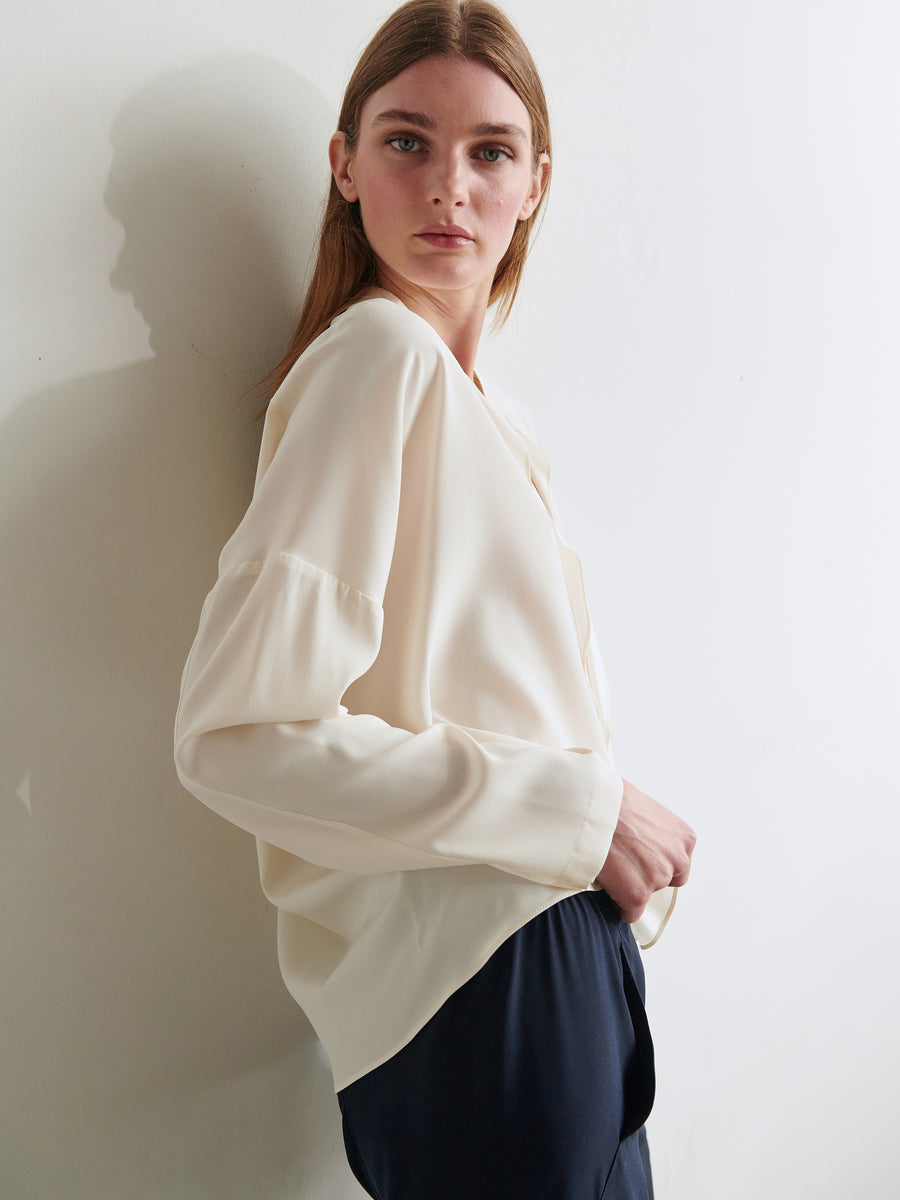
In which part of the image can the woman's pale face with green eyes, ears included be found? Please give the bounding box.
[331,56,548,308]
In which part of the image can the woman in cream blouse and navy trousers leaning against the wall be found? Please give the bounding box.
[176,0,694,1200]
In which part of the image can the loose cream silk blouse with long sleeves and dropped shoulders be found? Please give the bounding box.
[175,292,673,1090]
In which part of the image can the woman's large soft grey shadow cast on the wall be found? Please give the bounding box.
[0,55,360,1200]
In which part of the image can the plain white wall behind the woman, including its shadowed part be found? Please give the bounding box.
[0,0,900,1200]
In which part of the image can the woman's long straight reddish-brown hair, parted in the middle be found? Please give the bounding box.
[262,0,552,396]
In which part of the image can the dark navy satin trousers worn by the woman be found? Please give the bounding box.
[338,892,655,1200]
